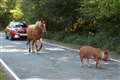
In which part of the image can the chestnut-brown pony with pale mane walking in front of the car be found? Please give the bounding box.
[27,21,46,52]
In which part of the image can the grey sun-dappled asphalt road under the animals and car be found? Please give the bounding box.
[0,34,120,80]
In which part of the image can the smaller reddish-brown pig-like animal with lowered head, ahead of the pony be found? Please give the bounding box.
[80,46,109,68]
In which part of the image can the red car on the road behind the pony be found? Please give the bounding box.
[5,21,27,40]
